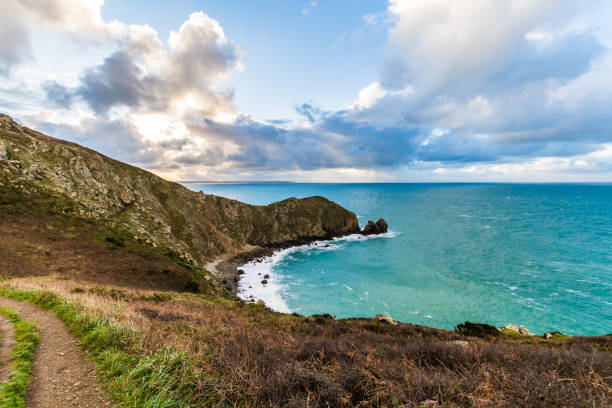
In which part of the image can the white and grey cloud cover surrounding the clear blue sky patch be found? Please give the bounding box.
[0,0,612,179]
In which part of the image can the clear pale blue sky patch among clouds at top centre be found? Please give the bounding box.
[102,0,387,119]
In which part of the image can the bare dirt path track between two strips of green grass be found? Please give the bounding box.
[0,297,113,408]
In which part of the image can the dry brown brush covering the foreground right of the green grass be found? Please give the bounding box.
[5,279,612,407]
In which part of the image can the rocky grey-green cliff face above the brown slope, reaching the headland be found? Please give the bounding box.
[0,115,359,268]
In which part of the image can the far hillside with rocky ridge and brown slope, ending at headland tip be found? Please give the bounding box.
[0,115,359,289]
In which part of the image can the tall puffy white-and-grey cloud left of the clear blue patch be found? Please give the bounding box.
[52,12,239,116]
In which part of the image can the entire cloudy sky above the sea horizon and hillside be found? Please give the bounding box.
[0,0,612,182]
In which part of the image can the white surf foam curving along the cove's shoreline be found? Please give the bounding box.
[238,231,400,313]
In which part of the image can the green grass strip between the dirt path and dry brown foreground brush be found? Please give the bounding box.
[0,286,206,408]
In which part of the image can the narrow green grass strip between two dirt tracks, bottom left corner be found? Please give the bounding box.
[0,306,39,408]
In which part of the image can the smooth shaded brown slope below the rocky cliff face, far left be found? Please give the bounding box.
[0,194,206,290]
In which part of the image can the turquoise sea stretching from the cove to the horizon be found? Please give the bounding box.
[189,184,612,335]
